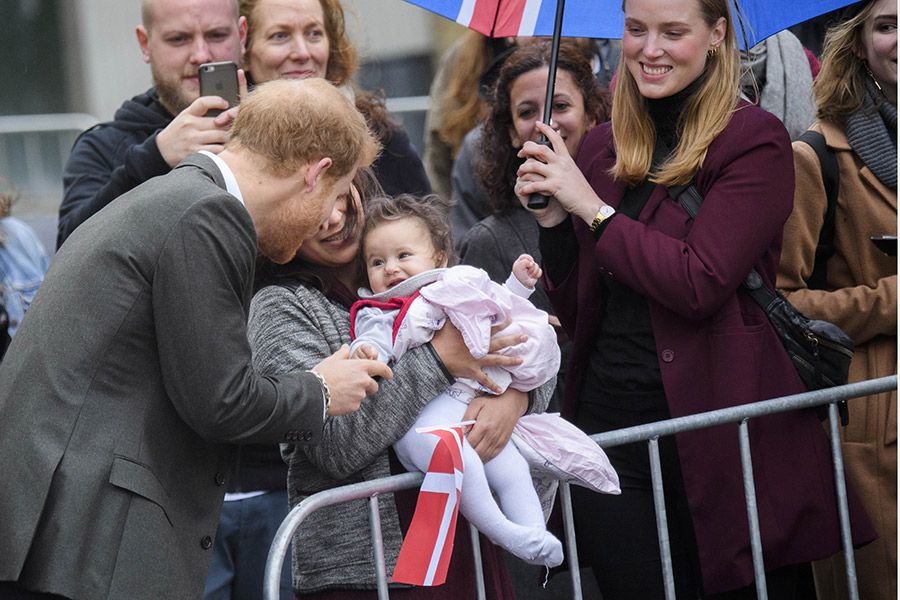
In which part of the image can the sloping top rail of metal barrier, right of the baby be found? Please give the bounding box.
[590,375,897,448]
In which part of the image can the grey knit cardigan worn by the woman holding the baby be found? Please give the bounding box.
[248,284,554,593]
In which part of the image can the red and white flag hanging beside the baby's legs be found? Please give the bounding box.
[393,426,463,586]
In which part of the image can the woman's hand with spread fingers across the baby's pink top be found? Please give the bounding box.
[431,319,528,393]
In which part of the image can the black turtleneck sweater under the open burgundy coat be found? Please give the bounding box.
[542,79,701,411]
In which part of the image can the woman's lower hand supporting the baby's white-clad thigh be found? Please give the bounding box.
[463,388,528,462]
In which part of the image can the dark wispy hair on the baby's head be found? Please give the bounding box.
[360,194,456,266]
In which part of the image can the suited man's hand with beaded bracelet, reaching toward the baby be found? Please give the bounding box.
[313,345,394,417]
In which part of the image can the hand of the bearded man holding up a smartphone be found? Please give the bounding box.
[156,96,236,167]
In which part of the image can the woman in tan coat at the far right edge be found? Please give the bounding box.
[778,0,897,599]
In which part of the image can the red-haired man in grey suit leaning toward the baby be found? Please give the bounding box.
[0,79,391,600]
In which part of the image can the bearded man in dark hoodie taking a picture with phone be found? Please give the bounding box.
[56,0,247,248]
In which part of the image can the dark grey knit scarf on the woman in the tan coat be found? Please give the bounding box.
[847,78,897,190]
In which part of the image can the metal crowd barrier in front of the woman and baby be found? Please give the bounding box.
[263,375,897,600]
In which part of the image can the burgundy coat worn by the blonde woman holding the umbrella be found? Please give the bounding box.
[545,104,873,593]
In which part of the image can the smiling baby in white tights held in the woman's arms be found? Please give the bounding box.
[350,195,563,567]
